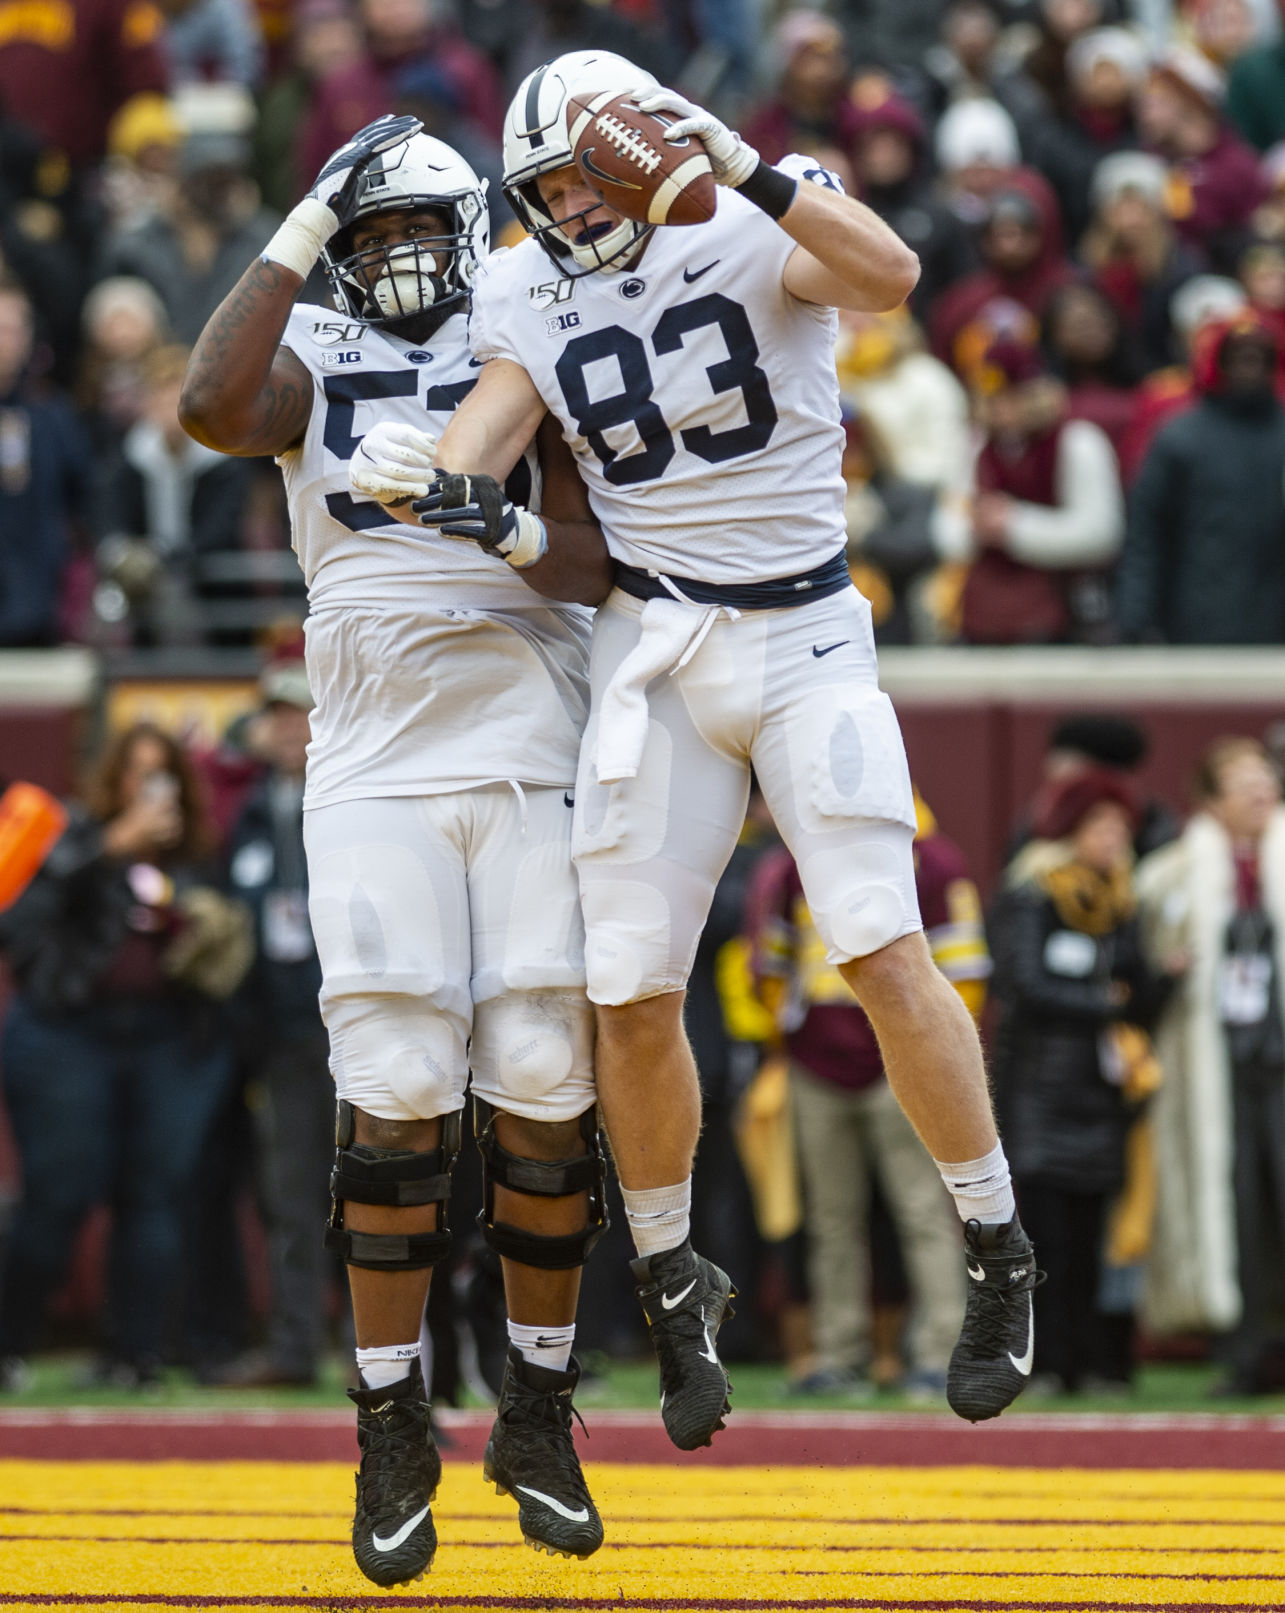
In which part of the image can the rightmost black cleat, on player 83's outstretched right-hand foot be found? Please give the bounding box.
[946,1216,1045,1423]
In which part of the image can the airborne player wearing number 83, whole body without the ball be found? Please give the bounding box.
[353,52,1037,1448]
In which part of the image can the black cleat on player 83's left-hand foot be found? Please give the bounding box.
[629,1239,737,1450]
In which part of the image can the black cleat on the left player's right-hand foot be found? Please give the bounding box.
[482,1348,603,1557]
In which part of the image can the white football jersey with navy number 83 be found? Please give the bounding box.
[469,156,846,584]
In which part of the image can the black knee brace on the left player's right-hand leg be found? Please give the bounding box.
[472,1097,611,1271]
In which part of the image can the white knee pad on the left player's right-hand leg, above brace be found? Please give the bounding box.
[471,990,595,1121]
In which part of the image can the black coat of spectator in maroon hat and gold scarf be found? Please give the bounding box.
[987,886,1161,1194]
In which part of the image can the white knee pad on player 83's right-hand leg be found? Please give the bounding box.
[798,823,922,963]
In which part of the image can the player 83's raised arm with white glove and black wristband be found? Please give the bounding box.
[638,89,919,313]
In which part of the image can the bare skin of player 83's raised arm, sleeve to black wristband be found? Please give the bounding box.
[780,182,919,313]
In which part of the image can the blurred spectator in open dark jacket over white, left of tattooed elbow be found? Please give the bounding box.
[94,347,253,644]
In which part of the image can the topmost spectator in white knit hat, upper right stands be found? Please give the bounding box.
[1024,27,1146,240]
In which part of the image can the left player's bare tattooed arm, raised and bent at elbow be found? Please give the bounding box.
[179,258,313,455]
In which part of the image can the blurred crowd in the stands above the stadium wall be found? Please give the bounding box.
[0,0,1285,648]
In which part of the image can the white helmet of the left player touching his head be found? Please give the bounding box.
[321,134,490,326]
